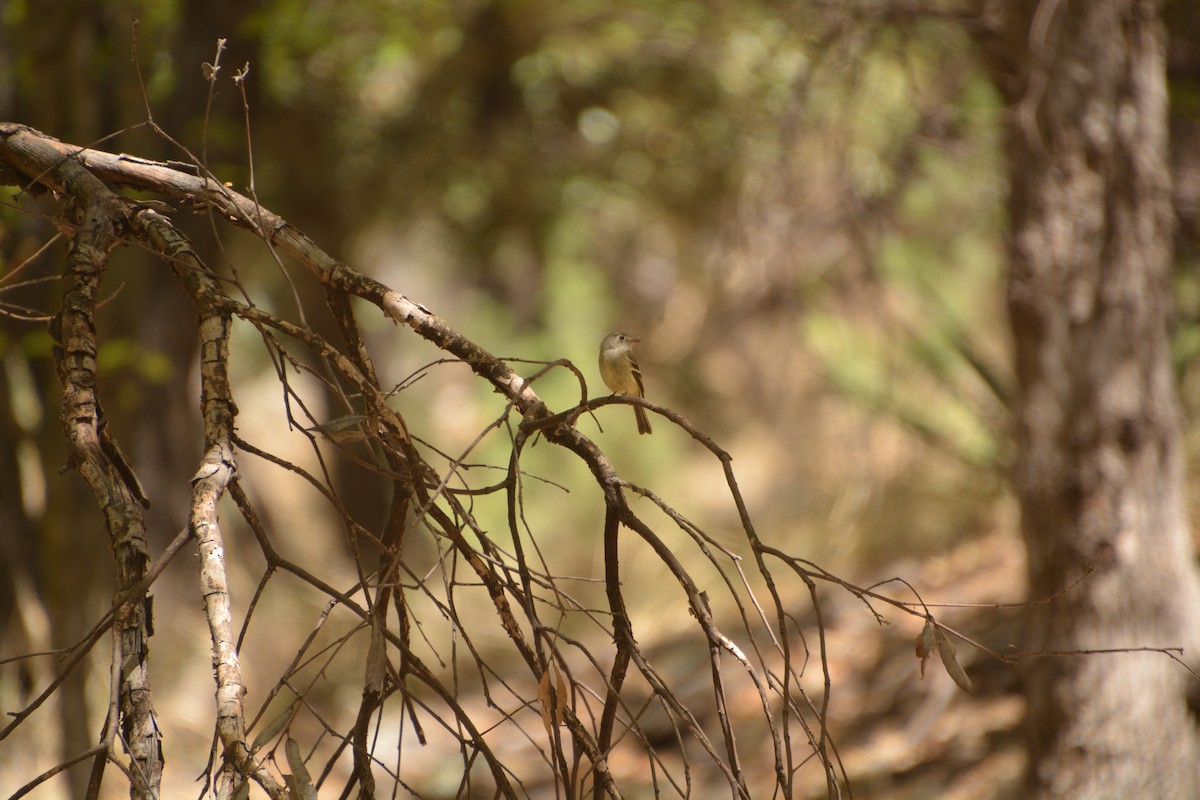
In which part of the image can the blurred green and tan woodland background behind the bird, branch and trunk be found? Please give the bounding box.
[0,0,1200,798]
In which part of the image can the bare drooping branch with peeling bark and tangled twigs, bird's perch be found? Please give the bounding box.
[0,117,1161,799]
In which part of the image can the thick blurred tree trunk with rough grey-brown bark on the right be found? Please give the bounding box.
[997,0,1200,798]
